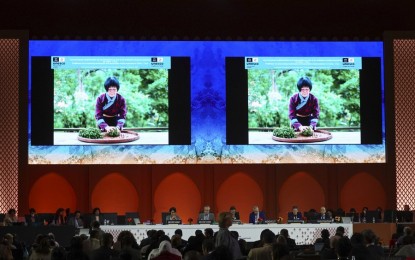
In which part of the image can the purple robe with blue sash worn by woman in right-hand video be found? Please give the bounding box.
[288,93,320,130]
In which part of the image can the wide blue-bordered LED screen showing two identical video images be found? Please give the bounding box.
[28,41,386,164]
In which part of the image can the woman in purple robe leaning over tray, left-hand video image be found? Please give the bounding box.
[95,77,127,132]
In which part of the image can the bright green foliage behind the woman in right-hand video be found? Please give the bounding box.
[248,69,360,128]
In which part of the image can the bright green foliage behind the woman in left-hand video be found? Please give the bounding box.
[54,69,168,128]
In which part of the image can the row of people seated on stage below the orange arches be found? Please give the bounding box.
[0,205,413,228]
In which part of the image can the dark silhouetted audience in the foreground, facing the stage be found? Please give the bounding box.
[0,212,415,260]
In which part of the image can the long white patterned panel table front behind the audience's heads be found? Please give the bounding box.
[96,223,353,245]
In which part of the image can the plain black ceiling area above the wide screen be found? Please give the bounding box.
[0,0,415,40]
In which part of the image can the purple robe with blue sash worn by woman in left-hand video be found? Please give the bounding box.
[95,93,127,131]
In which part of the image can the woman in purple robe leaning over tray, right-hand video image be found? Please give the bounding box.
[288,77,320,132]
